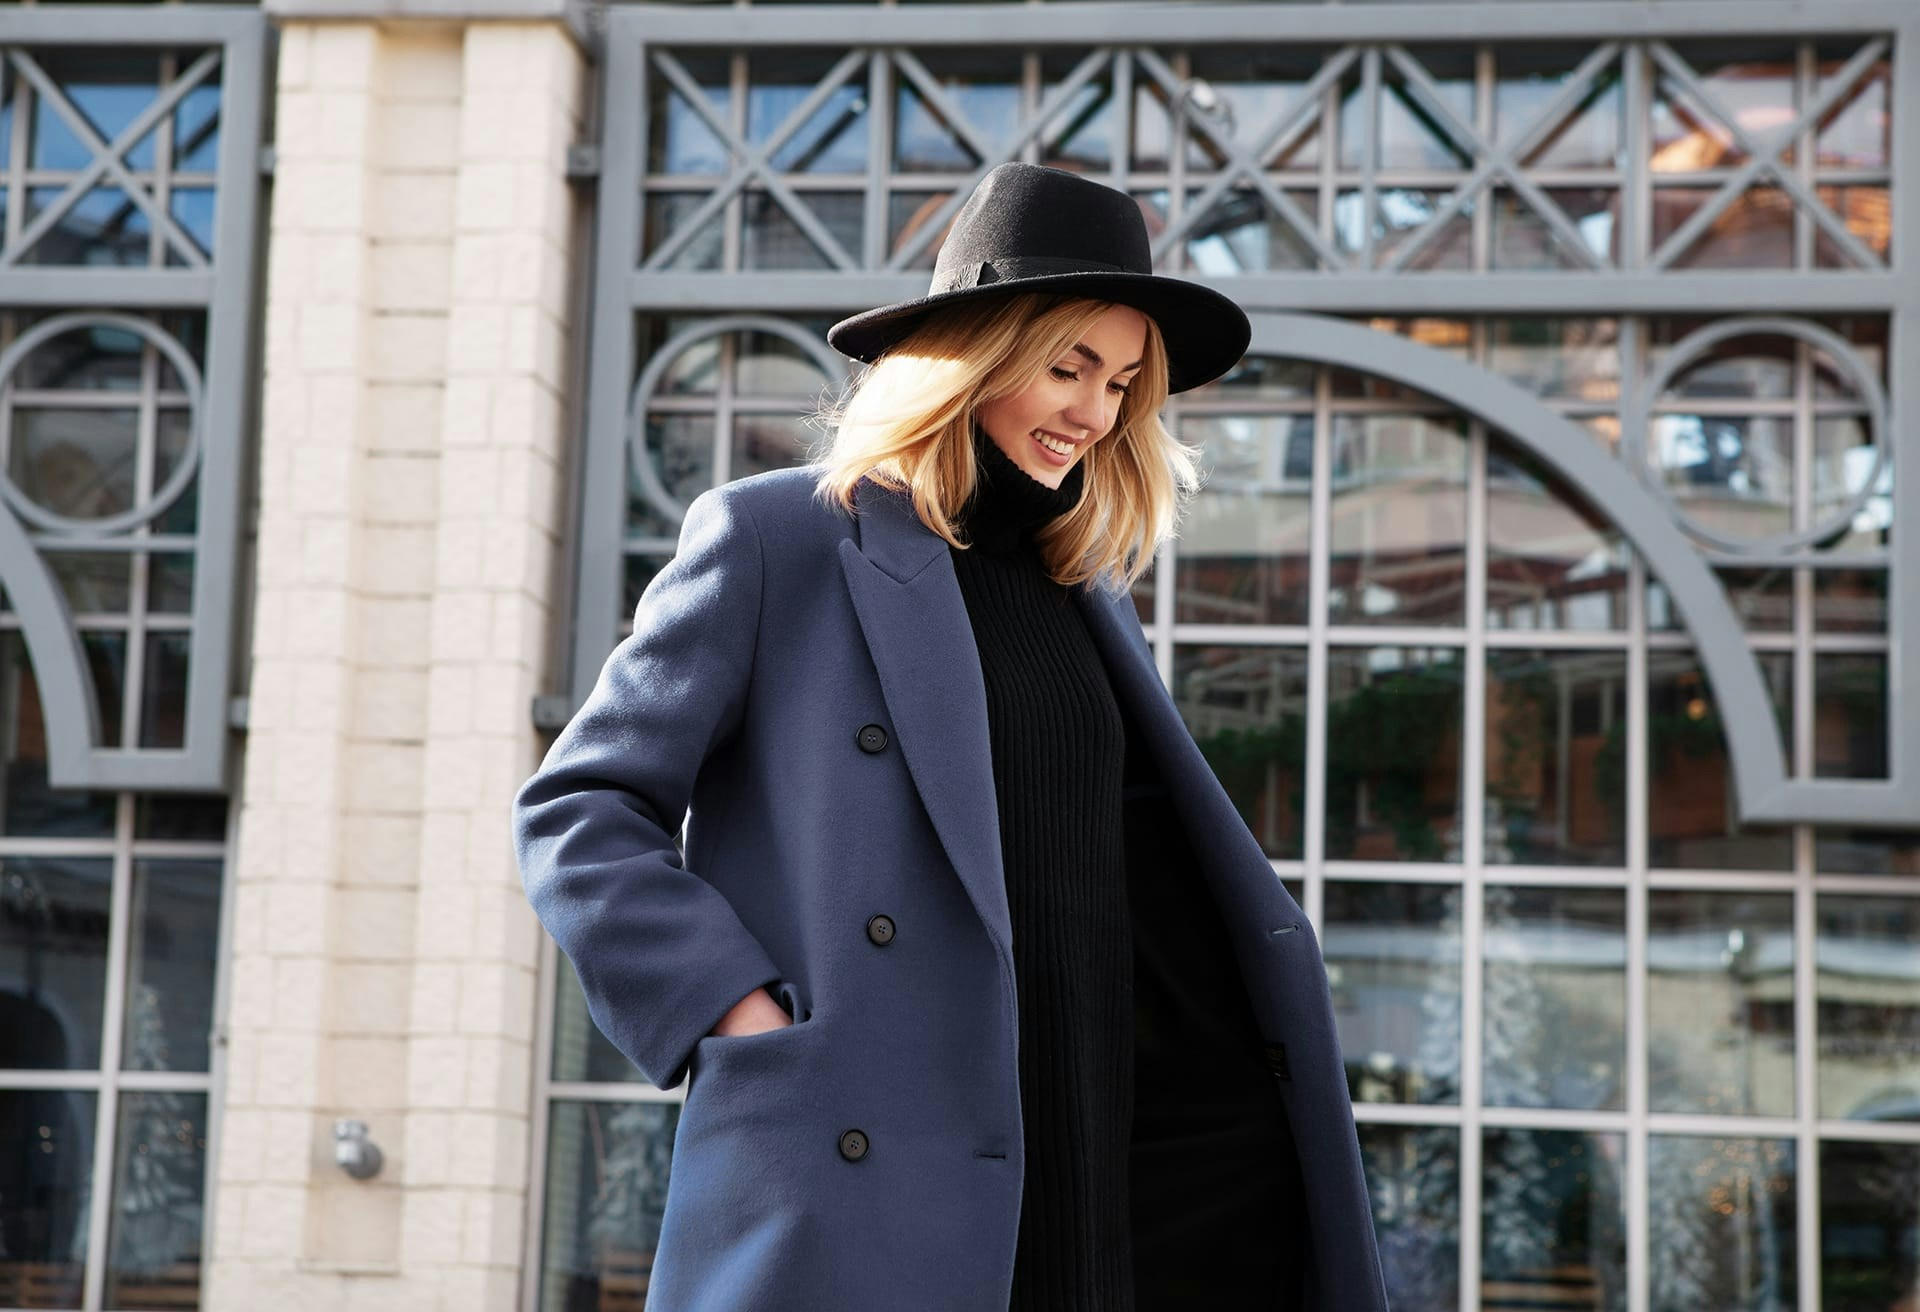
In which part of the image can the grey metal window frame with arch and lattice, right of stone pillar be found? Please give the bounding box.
[541,10,1920,1312]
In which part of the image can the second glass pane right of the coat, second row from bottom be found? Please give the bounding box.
[1482,884,1626,1110]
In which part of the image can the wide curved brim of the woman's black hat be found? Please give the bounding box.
[828,273,1254,392]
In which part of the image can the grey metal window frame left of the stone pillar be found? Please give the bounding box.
[0,6,269,791]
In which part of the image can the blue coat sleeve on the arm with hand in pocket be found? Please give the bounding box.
[513,488,780,1089]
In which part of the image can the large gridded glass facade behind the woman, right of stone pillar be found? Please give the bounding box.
[540,10,1920,1312]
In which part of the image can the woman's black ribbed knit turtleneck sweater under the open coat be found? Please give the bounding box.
[952,426,1133,1312]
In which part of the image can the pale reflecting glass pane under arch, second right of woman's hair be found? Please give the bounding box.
[1327,415,1467,624]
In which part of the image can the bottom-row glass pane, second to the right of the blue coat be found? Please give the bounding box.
[1480,1130,1626,1312]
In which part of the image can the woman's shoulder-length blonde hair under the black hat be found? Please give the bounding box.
[808,292,1200,590]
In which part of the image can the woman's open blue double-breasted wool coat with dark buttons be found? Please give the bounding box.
[515,469,1386,1312]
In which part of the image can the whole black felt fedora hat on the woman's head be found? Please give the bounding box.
[828,161,1252,392]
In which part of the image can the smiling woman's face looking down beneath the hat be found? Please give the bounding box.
[973,305,1146,488]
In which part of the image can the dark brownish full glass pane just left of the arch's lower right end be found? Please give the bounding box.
[1484,651,1626,866]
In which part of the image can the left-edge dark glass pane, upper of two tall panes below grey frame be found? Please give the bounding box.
[0,857,113,1070]
